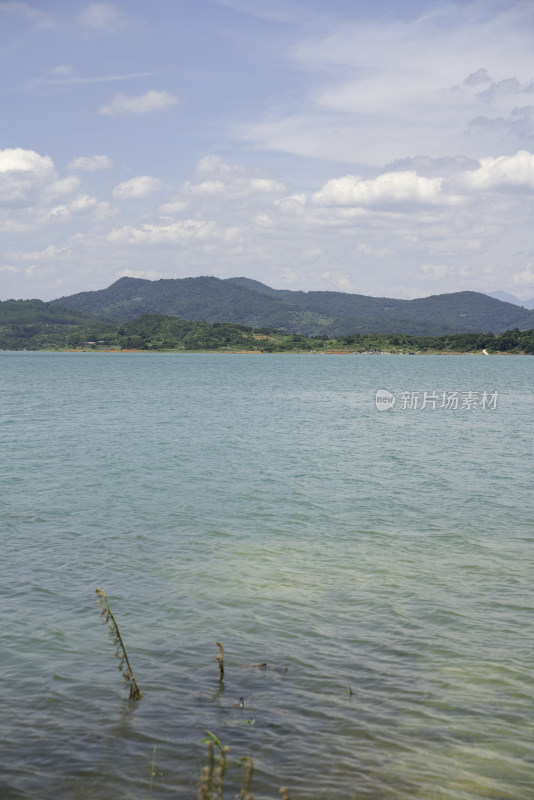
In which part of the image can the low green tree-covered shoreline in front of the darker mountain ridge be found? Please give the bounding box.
[0,293,534,354]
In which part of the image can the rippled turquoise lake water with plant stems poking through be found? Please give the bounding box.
[0,353,534,800]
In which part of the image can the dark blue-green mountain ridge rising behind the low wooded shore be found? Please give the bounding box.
[53,277,534,337]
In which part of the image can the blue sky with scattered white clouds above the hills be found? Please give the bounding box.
[0,0,534,300]
